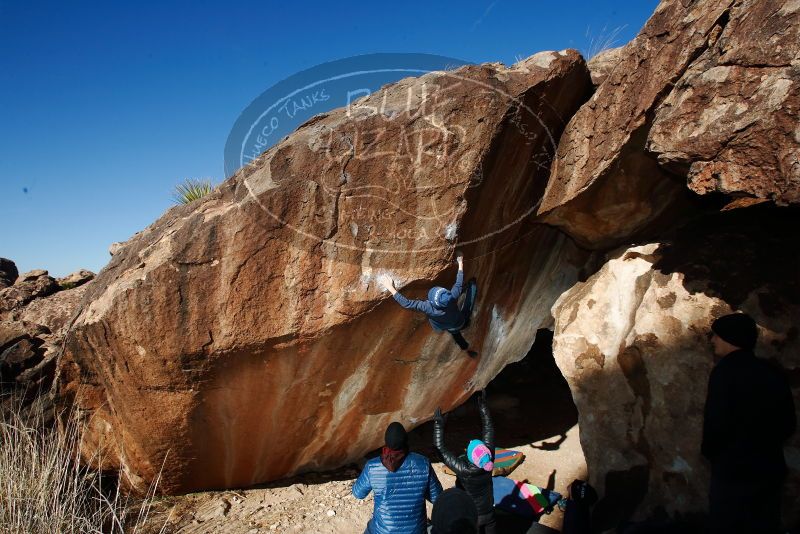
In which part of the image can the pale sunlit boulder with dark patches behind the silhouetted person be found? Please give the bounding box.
[553,207,800,528]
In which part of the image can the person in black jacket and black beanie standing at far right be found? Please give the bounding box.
[701,313,797,534]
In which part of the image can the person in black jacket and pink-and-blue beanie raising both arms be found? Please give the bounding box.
[433,390,496,534]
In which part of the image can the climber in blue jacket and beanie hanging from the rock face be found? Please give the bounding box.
[378,253,478,356]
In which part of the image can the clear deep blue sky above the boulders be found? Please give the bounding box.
[0,0,657,276]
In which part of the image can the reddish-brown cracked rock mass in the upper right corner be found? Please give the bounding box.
[539,0,800,248]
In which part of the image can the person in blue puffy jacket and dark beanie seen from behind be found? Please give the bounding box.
[353,422,442,534]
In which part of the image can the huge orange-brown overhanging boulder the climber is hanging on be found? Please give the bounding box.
[59,50,591,492]
